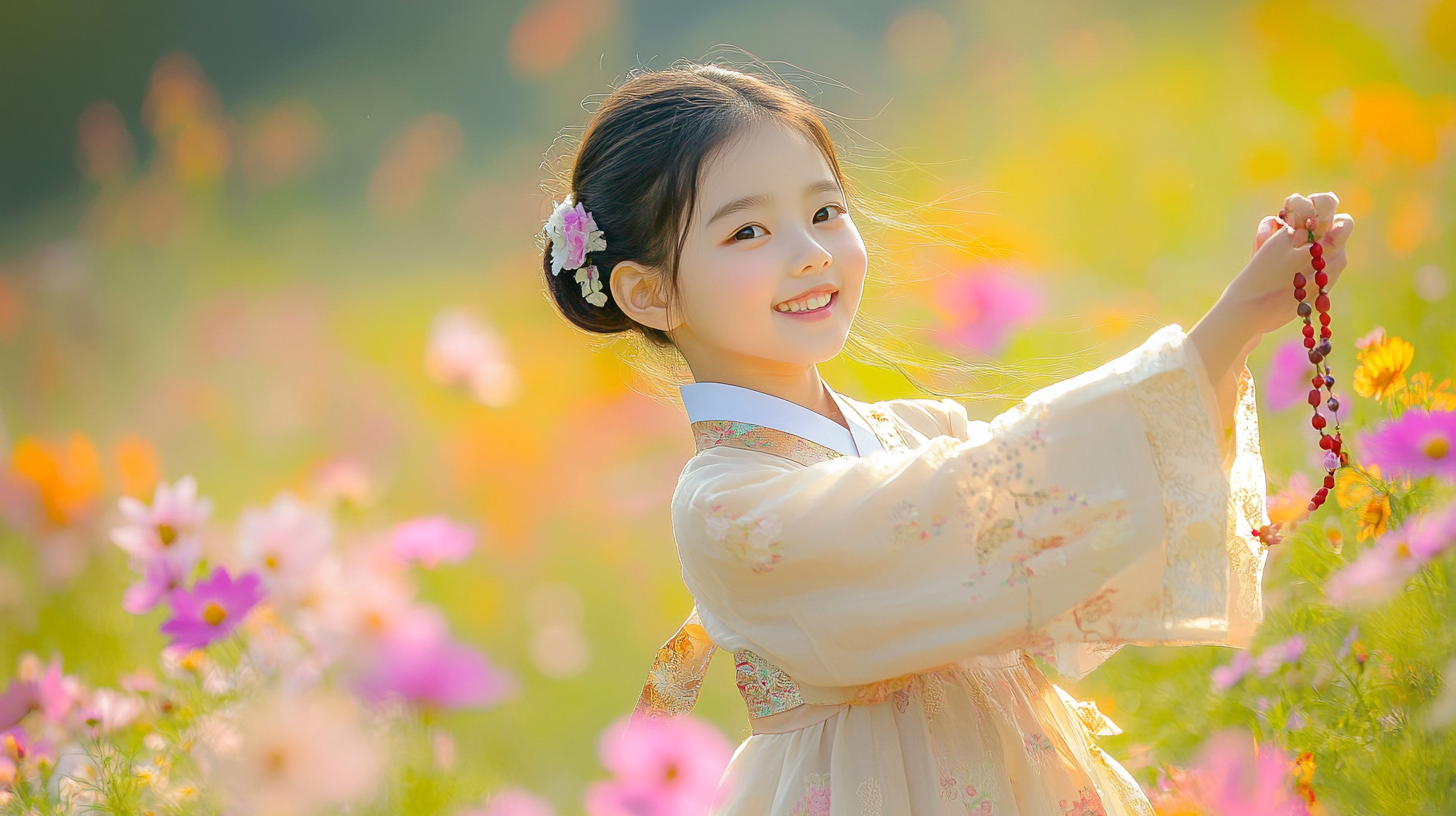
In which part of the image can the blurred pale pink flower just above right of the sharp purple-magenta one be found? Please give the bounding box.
[237,493,333,600]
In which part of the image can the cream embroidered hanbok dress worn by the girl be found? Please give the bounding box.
[636,325,1267,816]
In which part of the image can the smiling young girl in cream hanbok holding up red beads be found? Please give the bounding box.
[543,63,1353,816]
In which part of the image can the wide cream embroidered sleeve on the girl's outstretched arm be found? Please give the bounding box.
[673,325,1265,698]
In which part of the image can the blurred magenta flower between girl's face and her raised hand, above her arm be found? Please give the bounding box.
[933,267,1042,354]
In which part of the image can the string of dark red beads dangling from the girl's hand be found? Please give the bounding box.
[1252,210,1350,545]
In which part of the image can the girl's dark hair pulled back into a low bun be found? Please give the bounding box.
[542,63,849,347]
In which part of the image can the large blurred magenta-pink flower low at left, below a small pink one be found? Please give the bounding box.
[358,625,515,708]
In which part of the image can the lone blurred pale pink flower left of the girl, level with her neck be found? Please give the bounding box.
[425,309,521,408]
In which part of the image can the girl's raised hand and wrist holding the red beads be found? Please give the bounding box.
[1214,192,1354,341]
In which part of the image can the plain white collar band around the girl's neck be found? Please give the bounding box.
[678,383,884,456]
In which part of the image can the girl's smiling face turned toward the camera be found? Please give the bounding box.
[670,124,868,380]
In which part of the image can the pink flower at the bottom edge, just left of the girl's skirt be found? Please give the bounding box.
[584,714,732,816]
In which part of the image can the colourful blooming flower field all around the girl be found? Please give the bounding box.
[0,0,1456,816]
